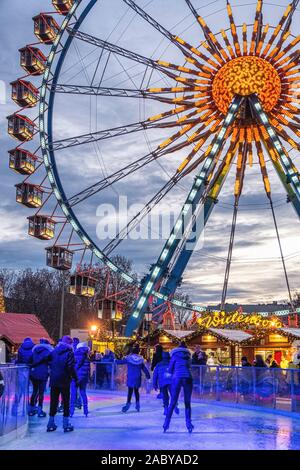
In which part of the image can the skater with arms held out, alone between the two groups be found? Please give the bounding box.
[117,344,150,413]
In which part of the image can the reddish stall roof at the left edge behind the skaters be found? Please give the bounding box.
[0,313,53,345]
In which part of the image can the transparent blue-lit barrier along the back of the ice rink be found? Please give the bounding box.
[88,362,300,413]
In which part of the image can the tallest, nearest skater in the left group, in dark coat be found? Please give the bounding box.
[47,336,77,432]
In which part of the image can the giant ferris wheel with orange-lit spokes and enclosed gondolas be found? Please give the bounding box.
[8,0,300,335]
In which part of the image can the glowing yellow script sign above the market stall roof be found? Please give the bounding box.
[197,312,283,328]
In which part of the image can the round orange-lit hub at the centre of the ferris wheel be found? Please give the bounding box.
[213,56,281,114]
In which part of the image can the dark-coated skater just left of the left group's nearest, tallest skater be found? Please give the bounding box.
[28,338,53,418]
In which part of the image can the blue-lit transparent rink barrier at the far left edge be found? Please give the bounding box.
[0,364,29,446]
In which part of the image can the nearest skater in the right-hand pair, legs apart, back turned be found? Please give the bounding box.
[163,341,194,433]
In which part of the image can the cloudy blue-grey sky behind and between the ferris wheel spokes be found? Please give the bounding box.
[0,0,300,304]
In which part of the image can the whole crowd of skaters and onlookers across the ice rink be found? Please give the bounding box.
[0,336,300,432]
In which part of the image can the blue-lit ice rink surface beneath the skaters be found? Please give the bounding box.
[2,392,300,450]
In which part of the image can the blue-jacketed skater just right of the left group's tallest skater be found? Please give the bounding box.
[70,343,91,417]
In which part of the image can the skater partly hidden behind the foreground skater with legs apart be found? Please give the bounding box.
[153,351,179,415]
